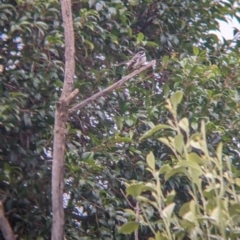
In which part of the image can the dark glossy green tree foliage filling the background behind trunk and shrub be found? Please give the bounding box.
[0,0,240,240]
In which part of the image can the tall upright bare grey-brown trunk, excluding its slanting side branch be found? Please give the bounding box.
[52,0,75,240]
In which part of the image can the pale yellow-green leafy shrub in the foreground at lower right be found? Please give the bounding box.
[122,92,240,240]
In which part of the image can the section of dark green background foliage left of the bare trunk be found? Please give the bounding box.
[0,1,63,239]
